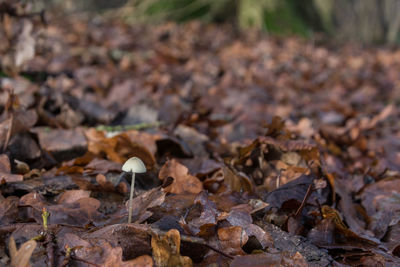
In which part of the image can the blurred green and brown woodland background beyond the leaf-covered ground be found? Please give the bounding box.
[35,0,400,44]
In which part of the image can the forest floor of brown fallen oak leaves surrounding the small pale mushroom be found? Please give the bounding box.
[0,9,400,267]
